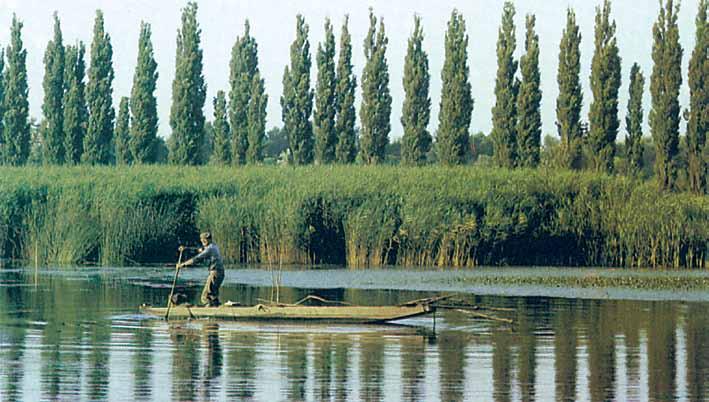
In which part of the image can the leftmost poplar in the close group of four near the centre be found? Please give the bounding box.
[281,14,313,165]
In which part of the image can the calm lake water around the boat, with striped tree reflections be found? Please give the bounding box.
[0,268,709,401]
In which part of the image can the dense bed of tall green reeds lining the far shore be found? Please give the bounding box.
[0,166,709,268]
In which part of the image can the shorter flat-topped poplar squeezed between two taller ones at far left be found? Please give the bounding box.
[62,42,89,164]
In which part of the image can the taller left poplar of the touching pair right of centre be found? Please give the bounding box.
[492,1,519,168]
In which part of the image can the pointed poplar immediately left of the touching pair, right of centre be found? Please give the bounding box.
[436,10,473,165]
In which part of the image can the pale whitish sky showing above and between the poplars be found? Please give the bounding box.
[0,0,698,139]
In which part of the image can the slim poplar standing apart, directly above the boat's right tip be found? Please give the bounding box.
[401,15,431,166]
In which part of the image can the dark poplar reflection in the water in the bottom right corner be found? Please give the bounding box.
[685,303,709,401]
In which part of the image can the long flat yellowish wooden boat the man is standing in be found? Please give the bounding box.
[140,303,435,324]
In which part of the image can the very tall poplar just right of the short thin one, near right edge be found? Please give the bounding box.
[649,0,682,190]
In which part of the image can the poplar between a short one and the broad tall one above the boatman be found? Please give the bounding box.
[130,22,158,163]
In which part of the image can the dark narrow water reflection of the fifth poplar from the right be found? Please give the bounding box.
[553,299,578,402]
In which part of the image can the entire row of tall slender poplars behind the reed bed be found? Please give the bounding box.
[0,0,709,192]
